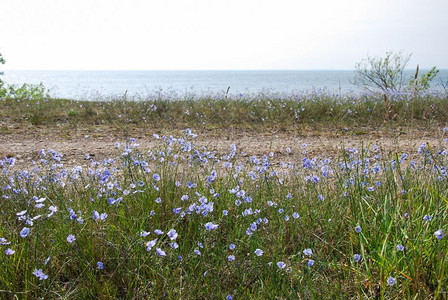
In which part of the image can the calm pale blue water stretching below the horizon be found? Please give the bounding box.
[3,70,448,100]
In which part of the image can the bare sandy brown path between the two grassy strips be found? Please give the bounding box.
[0,128,447,165]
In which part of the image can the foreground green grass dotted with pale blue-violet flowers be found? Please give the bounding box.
[0,129,448,299]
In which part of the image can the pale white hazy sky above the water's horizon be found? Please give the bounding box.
[0,0,448,70]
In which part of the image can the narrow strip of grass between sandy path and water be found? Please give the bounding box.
[0,91,448,131]
